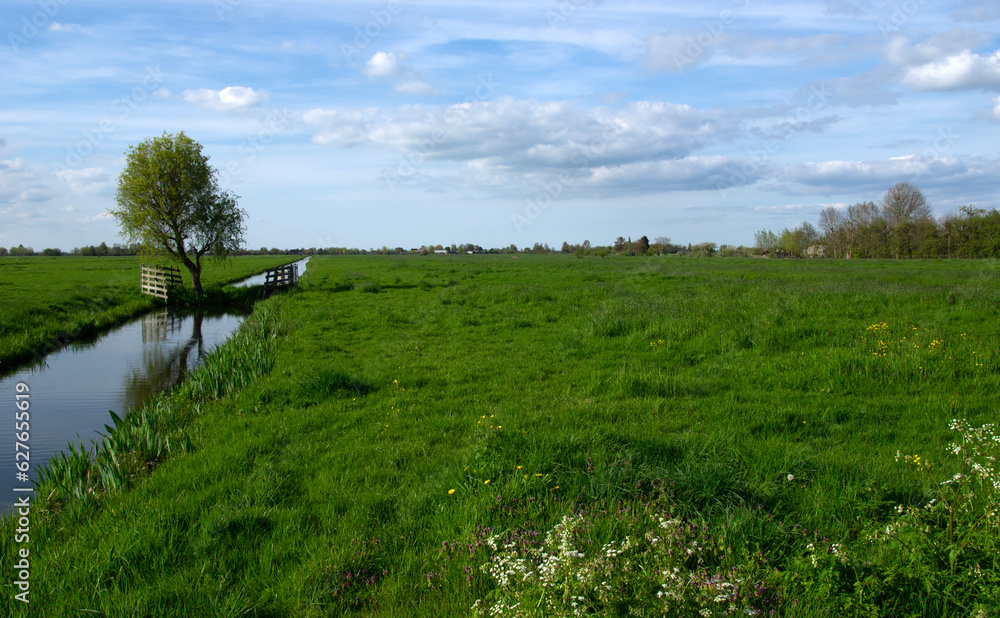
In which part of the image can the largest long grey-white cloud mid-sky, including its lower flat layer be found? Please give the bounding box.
[303,96,752,194]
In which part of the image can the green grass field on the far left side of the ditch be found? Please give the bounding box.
[0,256,298,374]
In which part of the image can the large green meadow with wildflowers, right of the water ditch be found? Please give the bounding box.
[0,256,1000,616]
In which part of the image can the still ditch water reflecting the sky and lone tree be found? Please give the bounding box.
[0,255,306,513]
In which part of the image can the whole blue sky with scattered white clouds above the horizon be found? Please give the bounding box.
[0,0,1000,251]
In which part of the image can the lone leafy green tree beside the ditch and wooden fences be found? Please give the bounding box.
[111,131,247,296]
